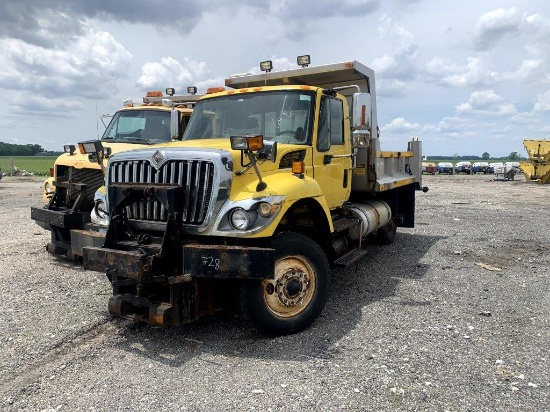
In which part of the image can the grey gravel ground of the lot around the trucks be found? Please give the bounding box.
[0,175,550,411]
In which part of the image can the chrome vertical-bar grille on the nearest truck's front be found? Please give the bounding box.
[109,160,214,225]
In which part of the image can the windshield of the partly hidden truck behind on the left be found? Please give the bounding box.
[101,110,170,144]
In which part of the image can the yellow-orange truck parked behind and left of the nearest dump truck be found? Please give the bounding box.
[31,87,200,260]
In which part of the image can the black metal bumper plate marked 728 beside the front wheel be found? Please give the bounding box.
[183,245,275,279]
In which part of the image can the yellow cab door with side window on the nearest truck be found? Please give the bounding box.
[313,95,352,209]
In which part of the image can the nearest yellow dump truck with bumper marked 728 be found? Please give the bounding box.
[76,56,427,335]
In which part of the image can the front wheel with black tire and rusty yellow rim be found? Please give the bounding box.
[241,232,330,336]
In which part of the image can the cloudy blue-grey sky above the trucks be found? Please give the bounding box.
[0,0,550,158]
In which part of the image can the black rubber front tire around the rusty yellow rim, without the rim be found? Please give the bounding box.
[241,232,330,336]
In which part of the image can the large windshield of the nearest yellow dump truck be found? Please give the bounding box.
[183,90,315,144]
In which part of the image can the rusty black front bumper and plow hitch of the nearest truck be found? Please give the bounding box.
[83,244,275,326]
